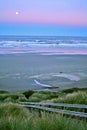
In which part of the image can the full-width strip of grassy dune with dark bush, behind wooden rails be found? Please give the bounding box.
[0,88,87,104]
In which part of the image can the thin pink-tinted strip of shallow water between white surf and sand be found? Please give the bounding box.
[0,48,87,55]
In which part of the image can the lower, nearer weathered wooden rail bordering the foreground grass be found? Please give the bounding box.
[22,105,87,118]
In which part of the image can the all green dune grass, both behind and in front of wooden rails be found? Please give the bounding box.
[0,88,87,130]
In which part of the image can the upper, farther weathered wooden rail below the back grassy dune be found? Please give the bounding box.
[20,102,87,109]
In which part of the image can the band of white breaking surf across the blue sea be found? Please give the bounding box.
[0,40,87,48]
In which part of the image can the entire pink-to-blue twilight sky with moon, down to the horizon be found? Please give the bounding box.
[0,0,87,36]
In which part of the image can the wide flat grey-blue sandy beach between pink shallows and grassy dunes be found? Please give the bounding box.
[0,53,87,91]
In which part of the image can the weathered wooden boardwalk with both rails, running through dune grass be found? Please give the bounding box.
[20,102,87,118]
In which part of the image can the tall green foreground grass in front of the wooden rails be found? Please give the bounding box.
[0,103,87,130]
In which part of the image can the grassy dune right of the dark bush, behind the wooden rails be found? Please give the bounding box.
[28,88,87,104]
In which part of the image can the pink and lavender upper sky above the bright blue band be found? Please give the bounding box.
[0,0,87,26]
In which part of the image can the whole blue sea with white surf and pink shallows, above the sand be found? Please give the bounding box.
[0,36,87,54]
